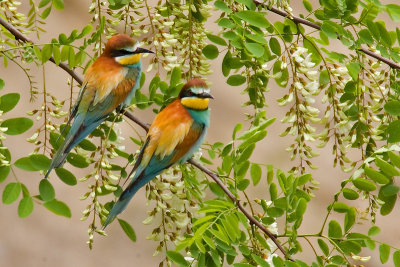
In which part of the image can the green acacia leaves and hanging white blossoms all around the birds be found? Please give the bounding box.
[0,0,400,267]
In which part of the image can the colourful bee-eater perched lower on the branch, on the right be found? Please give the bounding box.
[104,79,213,228]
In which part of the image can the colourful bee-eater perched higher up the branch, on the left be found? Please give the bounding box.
[45,34,153,178]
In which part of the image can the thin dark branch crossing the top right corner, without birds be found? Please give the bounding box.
[253,0,400,69]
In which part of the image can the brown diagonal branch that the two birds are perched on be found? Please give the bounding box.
[0,17,289,258]
